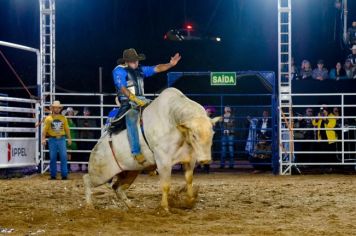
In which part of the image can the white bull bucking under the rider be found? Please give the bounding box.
[83,88,218,210]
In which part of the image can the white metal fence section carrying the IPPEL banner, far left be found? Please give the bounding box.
[0,95,39,168]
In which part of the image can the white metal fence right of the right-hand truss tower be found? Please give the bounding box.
[280,93,356,174]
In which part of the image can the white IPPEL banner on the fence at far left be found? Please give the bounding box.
[0,138,36,168]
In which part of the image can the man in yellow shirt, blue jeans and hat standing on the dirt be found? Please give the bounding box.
[42,101,72,180]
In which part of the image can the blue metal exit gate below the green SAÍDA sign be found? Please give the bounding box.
[168,71,279,174]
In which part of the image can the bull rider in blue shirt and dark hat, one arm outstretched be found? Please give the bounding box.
[112,48,181,164]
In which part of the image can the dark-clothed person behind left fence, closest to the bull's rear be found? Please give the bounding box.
[78,107,96,171]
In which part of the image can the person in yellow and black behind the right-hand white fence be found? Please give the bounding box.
[312,106,337,162]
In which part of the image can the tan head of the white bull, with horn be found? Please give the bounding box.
[178,116,220,164]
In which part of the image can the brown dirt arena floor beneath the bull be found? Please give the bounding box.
[0,173,356,235]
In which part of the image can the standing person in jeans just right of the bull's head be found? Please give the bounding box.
[220,106,235,169]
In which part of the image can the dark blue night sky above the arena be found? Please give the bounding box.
[0,0,356,96]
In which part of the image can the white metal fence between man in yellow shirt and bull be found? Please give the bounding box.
[41,93,117,173]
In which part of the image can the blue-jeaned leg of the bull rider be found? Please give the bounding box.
[126,109,141,155]
